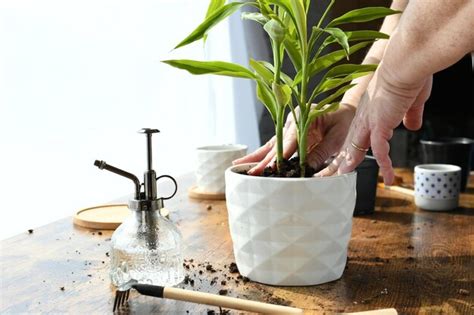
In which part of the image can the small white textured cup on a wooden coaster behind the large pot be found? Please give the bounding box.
[195,144,247,193]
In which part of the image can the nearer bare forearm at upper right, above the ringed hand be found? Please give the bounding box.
[378,0,474,92]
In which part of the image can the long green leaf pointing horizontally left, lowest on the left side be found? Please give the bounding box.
[162,59,255,79]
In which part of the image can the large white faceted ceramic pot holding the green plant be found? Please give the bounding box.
[225,164,357,286]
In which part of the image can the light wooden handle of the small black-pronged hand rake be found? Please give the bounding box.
[163,287,303,314]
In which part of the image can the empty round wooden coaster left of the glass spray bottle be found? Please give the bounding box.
[74,204,131,230]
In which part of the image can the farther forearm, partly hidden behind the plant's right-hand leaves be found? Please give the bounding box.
[341,0,408,106]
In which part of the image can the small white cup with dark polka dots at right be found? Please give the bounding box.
[415,164,461,211]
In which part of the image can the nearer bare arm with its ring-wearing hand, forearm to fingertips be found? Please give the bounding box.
[320,0,474,184]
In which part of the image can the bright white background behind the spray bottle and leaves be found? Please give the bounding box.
[0,0,259,239]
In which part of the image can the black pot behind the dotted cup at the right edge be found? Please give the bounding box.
[420,138,474,191]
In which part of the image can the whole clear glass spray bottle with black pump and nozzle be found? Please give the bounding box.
[94,128,184,287]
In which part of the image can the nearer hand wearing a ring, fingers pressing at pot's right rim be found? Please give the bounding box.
[316,68,432,185]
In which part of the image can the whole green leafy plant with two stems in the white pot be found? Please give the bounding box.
[163,0,399,177]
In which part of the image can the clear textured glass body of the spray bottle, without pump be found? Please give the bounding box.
[110,206,184,287]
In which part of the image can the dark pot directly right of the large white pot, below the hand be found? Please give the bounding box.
[354,155,379,215]
